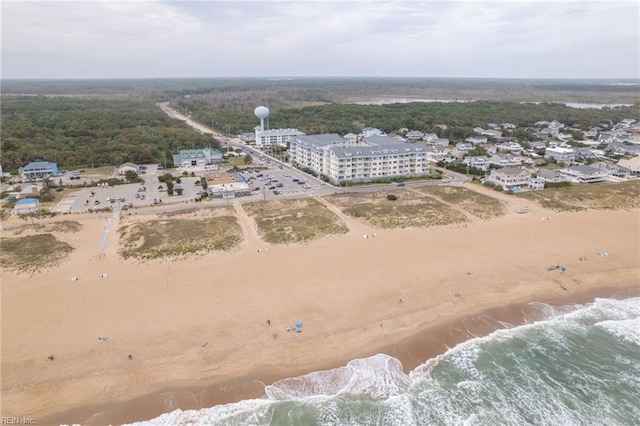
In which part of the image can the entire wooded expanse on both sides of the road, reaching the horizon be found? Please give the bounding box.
[0,78,640,172]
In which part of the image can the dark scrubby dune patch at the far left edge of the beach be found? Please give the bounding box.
[0,234,73,272]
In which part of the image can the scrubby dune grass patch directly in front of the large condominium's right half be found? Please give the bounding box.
[327,190,467,228]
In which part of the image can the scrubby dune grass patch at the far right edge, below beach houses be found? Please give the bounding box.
[516,180,640,211]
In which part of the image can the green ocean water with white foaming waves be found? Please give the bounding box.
[127,297,640,426]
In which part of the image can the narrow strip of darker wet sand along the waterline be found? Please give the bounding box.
[42,283,640,426]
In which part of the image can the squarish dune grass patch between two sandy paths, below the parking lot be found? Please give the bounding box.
[243,198,348,244]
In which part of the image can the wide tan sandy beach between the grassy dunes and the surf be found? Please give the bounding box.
[2,201,640,424]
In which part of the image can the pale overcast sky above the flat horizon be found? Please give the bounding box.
[1,0,640,78]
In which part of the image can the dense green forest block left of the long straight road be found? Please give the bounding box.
[1,96,219,172]
